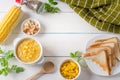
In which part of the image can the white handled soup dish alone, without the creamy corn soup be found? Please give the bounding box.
[14,37,44,64]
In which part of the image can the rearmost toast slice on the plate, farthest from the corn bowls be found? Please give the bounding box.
[95,37,120,60]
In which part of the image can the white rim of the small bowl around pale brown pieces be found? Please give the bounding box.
[21,18,41,36]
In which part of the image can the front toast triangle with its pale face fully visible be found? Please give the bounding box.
[82,49,111,75]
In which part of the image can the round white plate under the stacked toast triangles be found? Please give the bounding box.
[85,35,120,76]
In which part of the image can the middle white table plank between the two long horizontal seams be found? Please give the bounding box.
[1,34,117,57]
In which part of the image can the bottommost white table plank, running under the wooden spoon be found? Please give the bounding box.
[0,57,120,80]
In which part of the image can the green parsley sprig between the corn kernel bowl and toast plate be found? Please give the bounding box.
[70,51,87,68]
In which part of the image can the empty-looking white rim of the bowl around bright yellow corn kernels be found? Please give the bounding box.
[59,58,81,80]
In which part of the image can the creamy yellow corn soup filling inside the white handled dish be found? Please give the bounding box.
[17,39,40,62]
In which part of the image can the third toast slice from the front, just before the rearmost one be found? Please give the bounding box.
[90,42,117,66]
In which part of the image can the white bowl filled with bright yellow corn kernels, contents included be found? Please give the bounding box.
[59,59,81,80]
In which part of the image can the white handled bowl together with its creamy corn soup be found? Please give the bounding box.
[14,37,43,64]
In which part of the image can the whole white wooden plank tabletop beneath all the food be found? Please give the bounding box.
[0,0,120,80]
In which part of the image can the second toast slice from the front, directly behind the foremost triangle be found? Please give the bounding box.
[87,45,113,70]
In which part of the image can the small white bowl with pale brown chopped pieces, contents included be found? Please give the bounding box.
[21,18,41,36]
